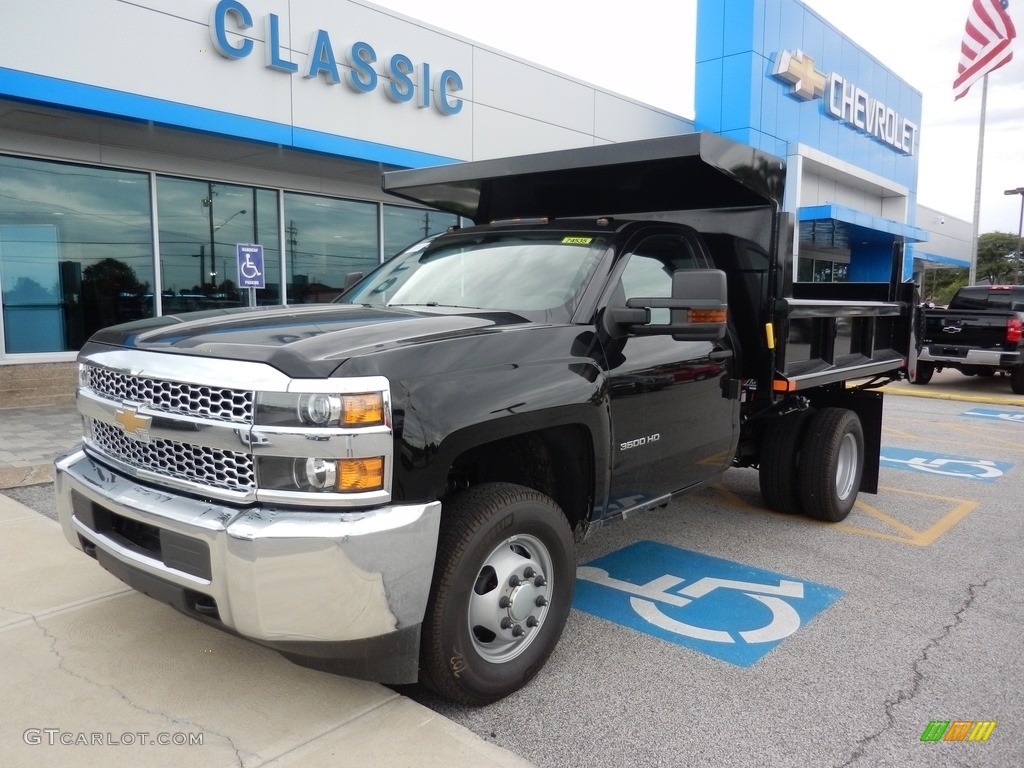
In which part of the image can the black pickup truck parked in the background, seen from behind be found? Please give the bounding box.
[910,285,1024,394]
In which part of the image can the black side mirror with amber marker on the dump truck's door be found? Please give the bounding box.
[608,269,728,341]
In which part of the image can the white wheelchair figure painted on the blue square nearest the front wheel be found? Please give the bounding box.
[577,565,804,643]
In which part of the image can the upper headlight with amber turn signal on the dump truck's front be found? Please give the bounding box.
[256,392,387,428]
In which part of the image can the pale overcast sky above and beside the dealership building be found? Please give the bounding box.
[364,0,1024,234]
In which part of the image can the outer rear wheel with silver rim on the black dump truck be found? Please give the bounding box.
[799,408,864,522]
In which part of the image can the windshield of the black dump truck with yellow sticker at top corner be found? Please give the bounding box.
[341,231,607,321]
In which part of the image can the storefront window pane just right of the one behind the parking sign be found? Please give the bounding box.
[285,193,380,304]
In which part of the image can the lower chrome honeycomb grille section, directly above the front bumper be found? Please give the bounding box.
[88,419,256,493]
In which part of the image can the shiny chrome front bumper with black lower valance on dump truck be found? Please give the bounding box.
[55,449,441,683]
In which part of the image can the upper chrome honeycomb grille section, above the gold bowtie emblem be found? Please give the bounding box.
[85,366,255,424]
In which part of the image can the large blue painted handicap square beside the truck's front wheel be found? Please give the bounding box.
[572,542,843,667]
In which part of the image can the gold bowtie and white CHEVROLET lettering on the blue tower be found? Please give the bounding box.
[771,50,919,155]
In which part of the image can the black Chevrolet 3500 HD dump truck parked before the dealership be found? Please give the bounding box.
[56,134,915,705]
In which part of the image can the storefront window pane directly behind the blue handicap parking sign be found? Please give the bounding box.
[157,176,281,314]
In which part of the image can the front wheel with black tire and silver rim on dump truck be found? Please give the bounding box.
[420,483,575,706]
